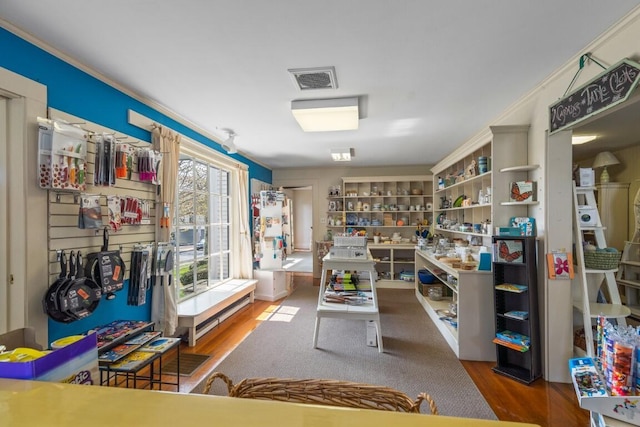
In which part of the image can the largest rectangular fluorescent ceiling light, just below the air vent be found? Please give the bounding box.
[291,97,359,132]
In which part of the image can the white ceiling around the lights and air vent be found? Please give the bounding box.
[0,0,640,168]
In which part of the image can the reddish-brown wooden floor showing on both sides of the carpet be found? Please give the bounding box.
[148,274,589,427]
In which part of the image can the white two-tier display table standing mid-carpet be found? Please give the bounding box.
[313,251,383,353]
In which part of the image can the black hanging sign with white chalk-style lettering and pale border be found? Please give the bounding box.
[549,59,640,133]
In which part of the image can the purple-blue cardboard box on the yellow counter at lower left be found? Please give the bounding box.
[0,328,100,385]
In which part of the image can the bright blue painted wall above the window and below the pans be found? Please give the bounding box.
[0,28,272,342]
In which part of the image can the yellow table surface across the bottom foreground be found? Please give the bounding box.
[0,379,532,427]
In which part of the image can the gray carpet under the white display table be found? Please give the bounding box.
[192,286,497,420]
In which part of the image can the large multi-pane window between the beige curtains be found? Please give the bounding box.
[174,153,233,301]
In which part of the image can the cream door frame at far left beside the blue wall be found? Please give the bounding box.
[0,67,49,344]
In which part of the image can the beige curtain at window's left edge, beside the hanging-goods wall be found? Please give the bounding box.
[151,125,181,336]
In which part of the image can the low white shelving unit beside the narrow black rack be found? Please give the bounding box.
[415,250,496,361]
